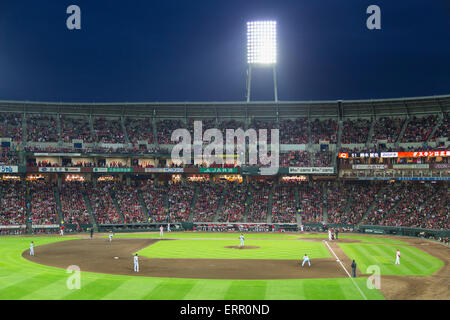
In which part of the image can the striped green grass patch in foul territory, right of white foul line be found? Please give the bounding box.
[339,243,444,276]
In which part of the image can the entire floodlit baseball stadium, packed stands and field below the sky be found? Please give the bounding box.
[0,96,450,300]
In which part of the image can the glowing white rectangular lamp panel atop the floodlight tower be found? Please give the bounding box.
[247,21,277,64]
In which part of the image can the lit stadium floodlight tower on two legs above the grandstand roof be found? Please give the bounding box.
[247,21,278,102]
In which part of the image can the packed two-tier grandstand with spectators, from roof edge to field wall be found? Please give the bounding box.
[0,96,450,241]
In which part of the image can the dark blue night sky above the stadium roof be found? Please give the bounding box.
[0,0,450,102]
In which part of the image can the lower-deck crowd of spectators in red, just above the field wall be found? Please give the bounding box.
[0,181,450,230]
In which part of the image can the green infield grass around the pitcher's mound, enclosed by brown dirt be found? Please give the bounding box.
[135,239,331,260]
